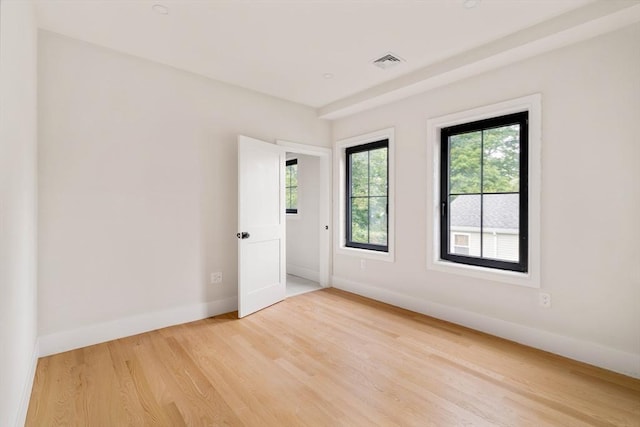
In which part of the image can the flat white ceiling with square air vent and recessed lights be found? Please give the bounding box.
[37,0,638,117]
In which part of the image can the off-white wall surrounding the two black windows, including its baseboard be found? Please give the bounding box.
[333,25,640,376]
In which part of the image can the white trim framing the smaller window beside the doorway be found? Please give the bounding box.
[334,127,396,262]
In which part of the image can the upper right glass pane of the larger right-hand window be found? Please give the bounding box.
[483,124,520,193]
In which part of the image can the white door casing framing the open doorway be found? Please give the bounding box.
[276,139,333,288]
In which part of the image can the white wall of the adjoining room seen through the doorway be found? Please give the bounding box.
[287,154,320,281]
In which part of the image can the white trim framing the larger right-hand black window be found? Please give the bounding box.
[427,93,542,288]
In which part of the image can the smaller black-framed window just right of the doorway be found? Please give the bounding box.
[345,139,389,252]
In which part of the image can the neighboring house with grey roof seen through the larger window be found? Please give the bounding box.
[449,194,520,261]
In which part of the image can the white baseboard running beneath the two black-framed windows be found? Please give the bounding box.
[332,276,640,378]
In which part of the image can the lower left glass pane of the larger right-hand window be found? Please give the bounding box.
[449,194,481,257]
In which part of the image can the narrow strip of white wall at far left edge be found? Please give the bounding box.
[0,0,37,426]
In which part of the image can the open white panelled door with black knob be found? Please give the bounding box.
[238,135,287,317]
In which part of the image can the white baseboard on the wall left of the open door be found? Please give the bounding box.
[39,297,238,357]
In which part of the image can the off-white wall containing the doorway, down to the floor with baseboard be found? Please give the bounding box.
[39,32,330,354]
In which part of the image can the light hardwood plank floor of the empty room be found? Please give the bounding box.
[27,289,640,427]
